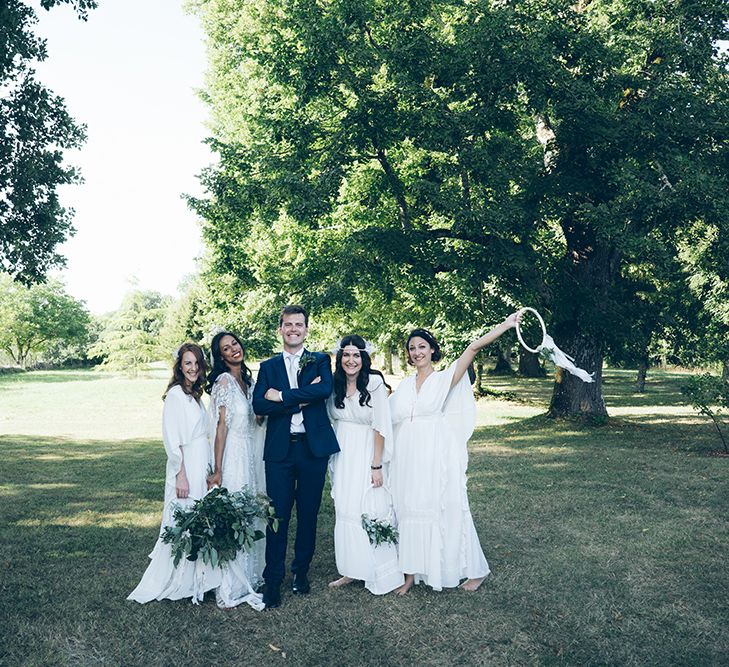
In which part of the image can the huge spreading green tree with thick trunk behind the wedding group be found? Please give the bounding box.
[189,0,729,416]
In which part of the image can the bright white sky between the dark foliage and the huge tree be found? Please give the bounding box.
[36,0,214,313]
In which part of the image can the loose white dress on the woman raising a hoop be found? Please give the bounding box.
[390,364,489,590]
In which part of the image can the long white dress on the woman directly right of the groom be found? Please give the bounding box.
[327,375,404,595]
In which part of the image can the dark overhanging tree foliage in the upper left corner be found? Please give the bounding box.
[0,0,96,283]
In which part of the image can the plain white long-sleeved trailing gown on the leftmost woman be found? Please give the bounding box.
[127,385,220,604]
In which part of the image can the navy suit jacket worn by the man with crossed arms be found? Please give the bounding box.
[253,352,339,461]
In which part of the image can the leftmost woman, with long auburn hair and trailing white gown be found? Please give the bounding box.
[127,343,220,603]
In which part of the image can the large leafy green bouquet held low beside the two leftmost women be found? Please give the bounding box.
[162,487,278,567]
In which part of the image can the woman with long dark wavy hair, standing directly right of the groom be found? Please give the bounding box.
[327,335,403,595]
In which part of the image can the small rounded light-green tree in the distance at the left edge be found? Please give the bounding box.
[0,274,91,367]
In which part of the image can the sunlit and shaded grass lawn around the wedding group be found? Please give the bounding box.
[0,371,729,665]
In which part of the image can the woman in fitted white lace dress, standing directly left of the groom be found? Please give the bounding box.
[206,331,266,611]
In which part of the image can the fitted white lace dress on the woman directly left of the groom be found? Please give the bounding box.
[210,373,266,611]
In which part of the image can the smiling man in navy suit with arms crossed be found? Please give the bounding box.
[253,306,339,609]
